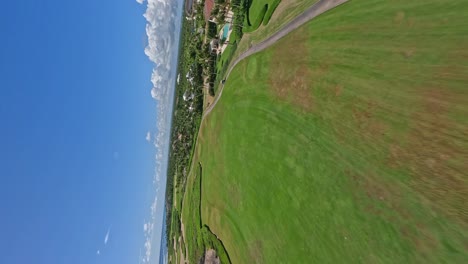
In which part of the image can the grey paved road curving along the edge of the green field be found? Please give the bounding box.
[202,0,348,117]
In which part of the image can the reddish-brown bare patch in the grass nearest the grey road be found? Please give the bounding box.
[269,29,316,112]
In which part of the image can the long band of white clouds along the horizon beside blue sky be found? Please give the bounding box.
[136,0,183,263]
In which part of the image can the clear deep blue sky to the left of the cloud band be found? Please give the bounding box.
[0,0,160,264]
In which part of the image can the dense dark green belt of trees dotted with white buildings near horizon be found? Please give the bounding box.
[166,9,209,255]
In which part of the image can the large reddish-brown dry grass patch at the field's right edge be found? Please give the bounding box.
[406,88,468,224]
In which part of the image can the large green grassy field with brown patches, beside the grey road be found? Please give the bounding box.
[196,0,468,263]
